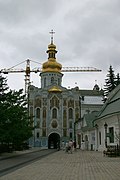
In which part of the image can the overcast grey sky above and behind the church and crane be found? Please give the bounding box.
[0,0,120,89]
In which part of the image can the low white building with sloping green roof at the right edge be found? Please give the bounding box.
[94,85,120,151]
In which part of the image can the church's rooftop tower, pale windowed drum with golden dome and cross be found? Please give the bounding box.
[40,30,63,88]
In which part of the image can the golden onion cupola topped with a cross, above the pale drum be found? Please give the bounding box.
[42,31,62,72]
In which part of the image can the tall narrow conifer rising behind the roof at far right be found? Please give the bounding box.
[104,65,116,97]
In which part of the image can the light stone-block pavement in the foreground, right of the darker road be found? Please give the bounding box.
[0,150,120,180]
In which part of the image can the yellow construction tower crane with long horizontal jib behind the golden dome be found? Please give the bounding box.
[0,59,101,94]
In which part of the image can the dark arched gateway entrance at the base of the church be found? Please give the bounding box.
[48,133,60,149]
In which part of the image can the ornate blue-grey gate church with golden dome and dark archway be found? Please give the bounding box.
[29,35,103,148]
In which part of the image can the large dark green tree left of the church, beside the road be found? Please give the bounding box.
[0,76,32,151]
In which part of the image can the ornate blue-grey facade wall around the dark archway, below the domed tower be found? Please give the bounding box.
[29,86,101,149]
